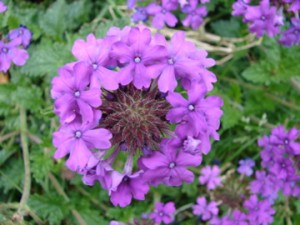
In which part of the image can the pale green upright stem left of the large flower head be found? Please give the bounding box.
[17,106,31,221]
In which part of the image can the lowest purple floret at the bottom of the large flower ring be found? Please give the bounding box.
[109,171,149,207]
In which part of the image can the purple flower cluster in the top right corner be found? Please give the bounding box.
[232,0,300,46]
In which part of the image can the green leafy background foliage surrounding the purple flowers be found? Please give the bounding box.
[0,0,300,225]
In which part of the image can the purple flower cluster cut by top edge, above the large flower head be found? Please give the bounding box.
[128,0,210,30]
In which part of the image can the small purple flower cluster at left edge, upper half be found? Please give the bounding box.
[0,23,32,73]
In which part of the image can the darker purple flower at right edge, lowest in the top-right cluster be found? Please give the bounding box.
[279,18,300,46]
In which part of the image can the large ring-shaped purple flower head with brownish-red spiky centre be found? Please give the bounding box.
[51,26,223,207]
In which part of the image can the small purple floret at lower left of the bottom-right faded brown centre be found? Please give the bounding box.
[193,197,219,221]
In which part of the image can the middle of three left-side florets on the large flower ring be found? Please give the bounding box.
[51,63,101,123]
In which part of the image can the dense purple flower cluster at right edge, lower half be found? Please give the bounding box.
[250,126,300,200]
